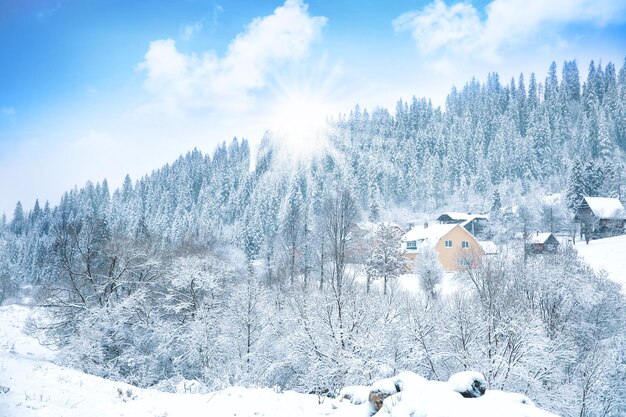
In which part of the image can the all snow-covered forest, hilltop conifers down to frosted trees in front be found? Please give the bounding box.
[0,61,626,416]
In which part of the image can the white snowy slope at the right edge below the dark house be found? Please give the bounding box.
[575,235,626,294]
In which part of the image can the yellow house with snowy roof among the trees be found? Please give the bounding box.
[402,223,485,272]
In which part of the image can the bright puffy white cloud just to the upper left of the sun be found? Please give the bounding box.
[138,0,326,116]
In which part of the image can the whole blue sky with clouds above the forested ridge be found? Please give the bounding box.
[0,0,626,215]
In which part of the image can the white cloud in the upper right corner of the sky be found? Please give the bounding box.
[393,0,626,60]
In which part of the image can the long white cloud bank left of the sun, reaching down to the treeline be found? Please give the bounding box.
[0,0,326,215]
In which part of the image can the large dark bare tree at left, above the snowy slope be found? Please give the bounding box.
[45,218,158,340]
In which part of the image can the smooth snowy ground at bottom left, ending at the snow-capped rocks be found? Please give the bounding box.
[0,305,338,417]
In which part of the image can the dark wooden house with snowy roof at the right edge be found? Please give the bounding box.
[574,197,626,239]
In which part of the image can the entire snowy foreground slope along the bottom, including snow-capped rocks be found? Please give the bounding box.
[0,305,553,417]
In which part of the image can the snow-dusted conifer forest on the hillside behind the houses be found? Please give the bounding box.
[2,57,626,260]
